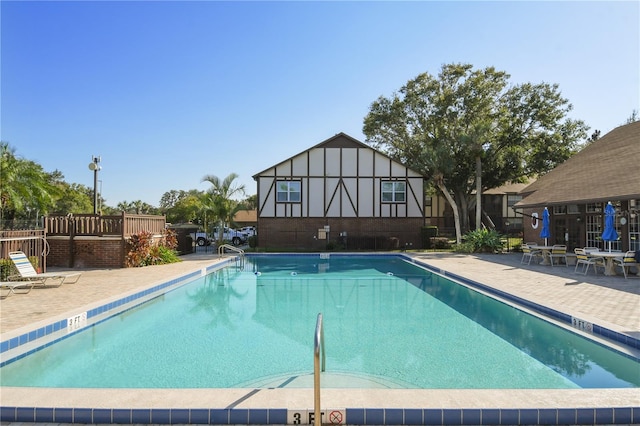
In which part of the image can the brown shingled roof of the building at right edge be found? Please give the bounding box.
[515,121,640,208]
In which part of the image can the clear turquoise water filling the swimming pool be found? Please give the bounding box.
[0,255,640,389]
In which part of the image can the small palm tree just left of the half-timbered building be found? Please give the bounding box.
[202,173,245,243]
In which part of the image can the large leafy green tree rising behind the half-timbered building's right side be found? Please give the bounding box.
[363,64,588,242]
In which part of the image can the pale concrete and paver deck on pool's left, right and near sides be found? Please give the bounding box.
[0,253,640,424]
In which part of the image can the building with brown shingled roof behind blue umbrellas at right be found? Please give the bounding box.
[514,121,640,251]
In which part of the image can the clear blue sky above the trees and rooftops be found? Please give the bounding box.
[0,0,640,206]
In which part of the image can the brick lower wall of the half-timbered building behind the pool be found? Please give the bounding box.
[258,218,424,250]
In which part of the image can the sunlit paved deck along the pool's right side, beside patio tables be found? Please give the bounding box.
[414,253,640,338]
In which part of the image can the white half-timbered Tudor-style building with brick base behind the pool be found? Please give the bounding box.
[253,133,425,250]
